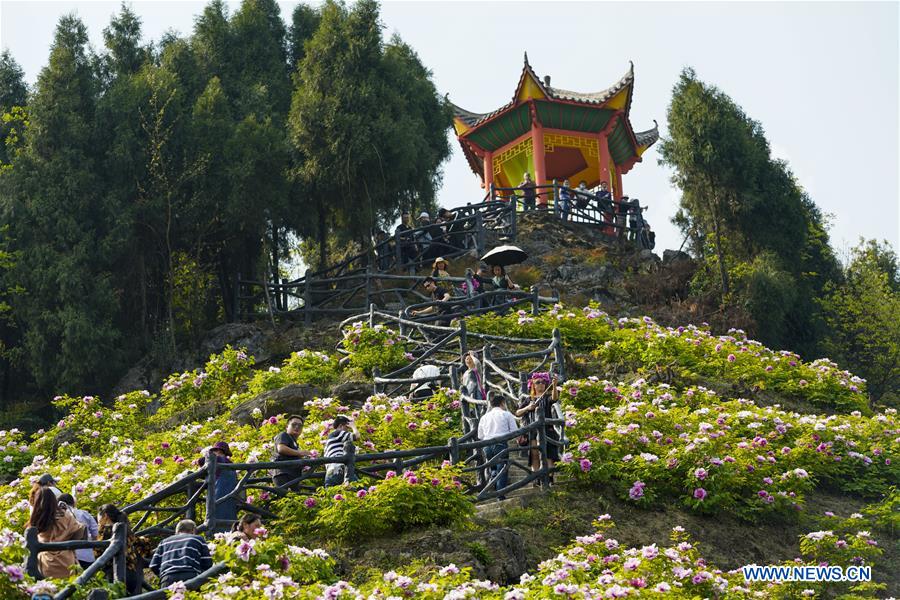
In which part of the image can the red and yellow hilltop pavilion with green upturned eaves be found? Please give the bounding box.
[453,54,659,199]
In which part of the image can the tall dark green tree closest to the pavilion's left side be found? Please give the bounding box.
[290,0,450,266]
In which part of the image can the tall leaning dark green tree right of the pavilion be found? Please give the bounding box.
[660,69,838,355]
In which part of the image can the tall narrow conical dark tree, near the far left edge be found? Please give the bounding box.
[7,16,121,392]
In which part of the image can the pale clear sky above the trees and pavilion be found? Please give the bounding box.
[0,0,900,257]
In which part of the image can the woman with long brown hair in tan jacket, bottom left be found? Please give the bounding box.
[28,487,87,579]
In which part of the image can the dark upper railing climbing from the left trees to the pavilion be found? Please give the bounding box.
[232,181,648,323]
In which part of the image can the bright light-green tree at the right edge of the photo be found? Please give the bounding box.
[820,243,900,406]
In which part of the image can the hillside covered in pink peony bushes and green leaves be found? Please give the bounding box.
[0,298,900,599]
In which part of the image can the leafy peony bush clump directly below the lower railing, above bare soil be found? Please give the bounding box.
[275,463,474,542]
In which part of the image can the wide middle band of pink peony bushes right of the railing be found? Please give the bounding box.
[562,379,900,519]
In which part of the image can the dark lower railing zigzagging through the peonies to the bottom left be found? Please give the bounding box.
[25,312,565,600]
